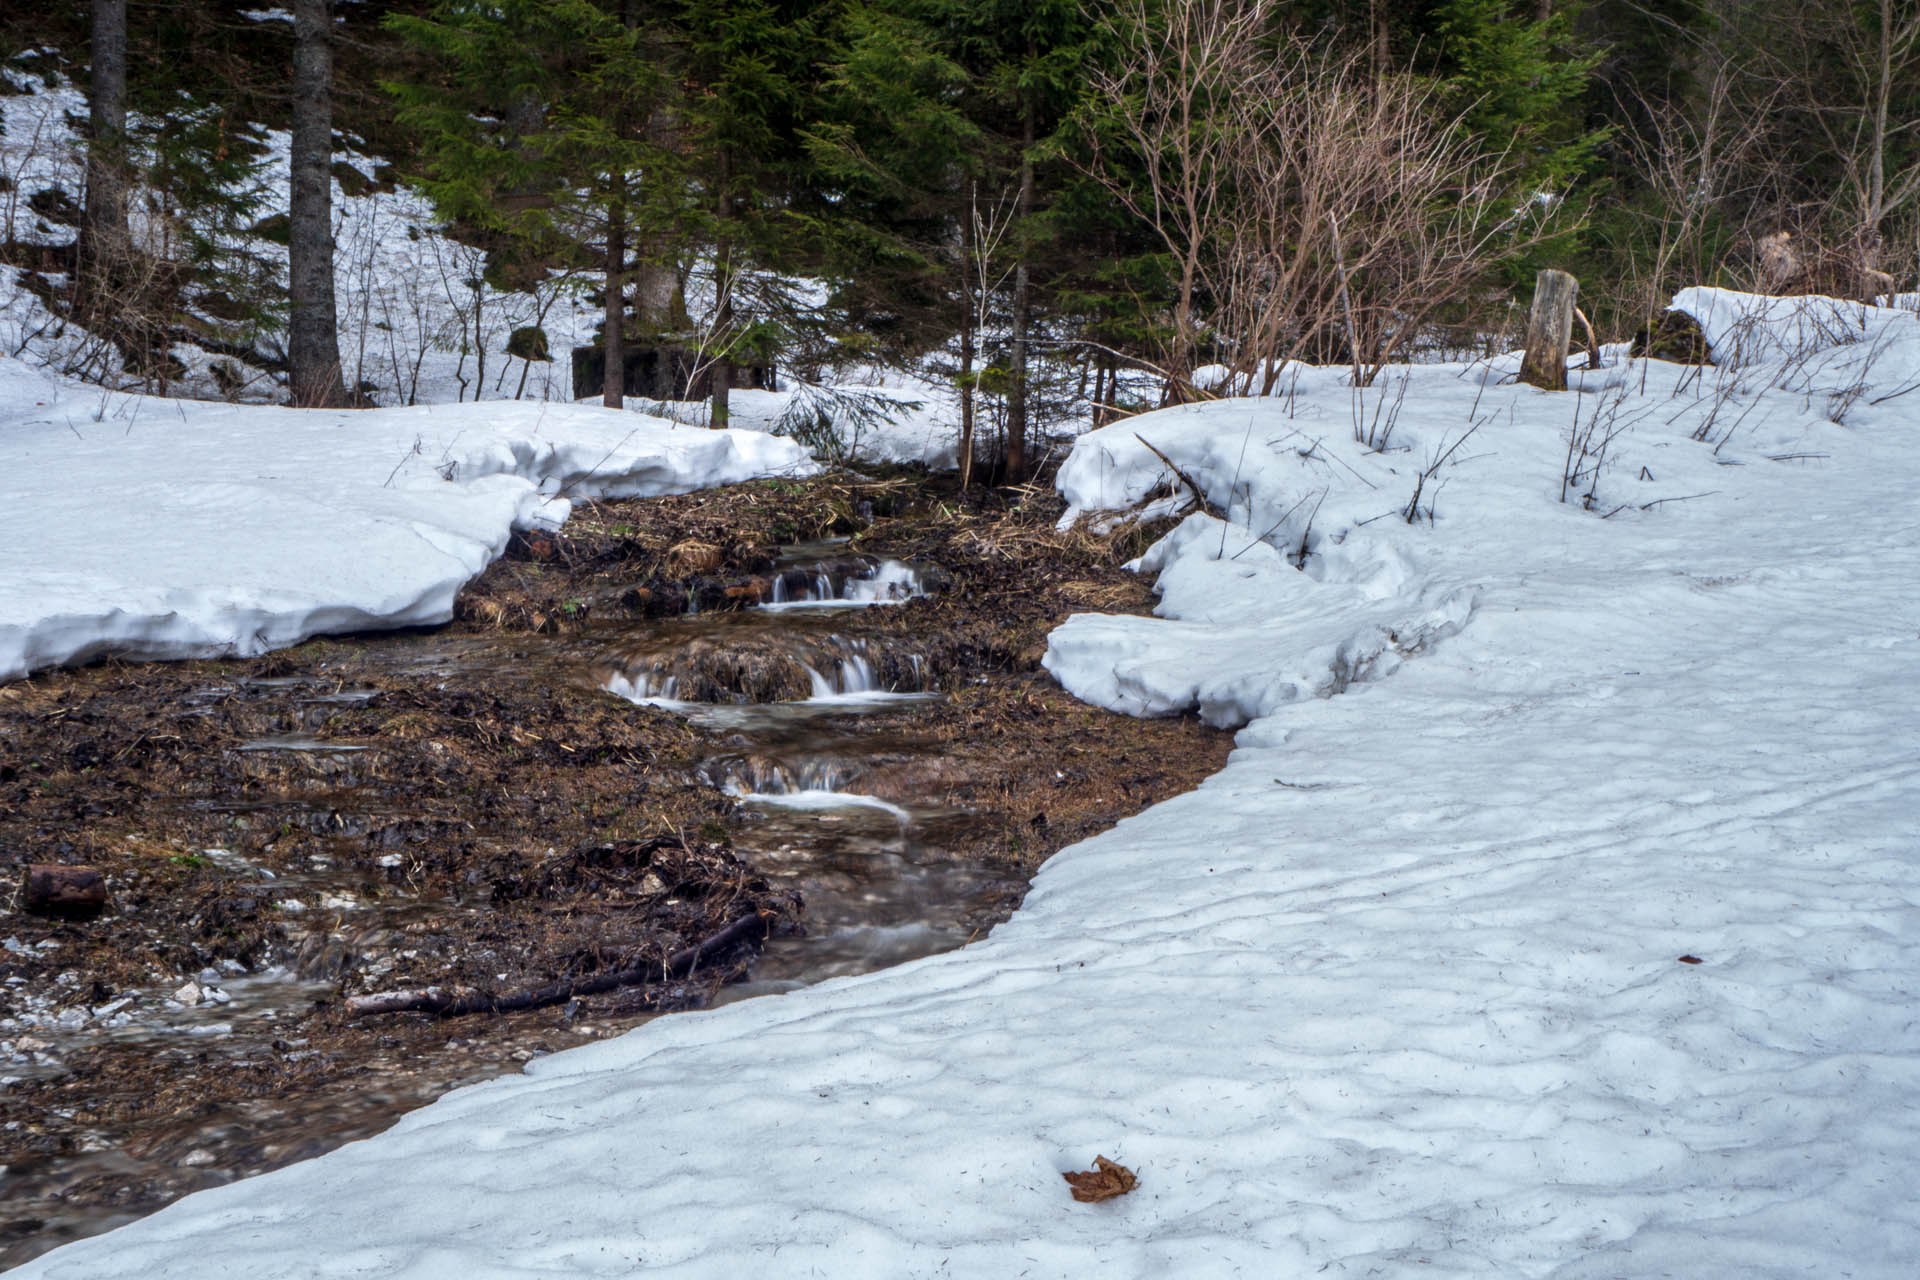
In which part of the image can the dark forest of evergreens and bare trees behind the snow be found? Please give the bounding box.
[0,0,1920,480]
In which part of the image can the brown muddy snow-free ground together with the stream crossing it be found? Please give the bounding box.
[0,476,1229,1267]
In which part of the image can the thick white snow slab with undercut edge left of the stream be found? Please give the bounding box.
[0,361,818,679]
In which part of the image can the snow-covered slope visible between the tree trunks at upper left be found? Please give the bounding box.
[0,76,958,466]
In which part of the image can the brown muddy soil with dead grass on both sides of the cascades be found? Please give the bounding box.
[0,466,1229,1267]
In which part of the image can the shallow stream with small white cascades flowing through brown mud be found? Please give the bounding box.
[0,543,1023,1265]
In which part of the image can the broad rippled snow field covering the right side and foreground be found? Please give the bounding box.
[15,294,1920,1280]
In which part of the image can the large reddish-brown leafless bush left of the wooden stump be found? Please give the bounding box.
[1087,0,1553,397]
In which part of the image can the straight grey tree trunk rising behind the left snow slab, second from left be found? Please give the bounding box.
[286,0,348,407]
